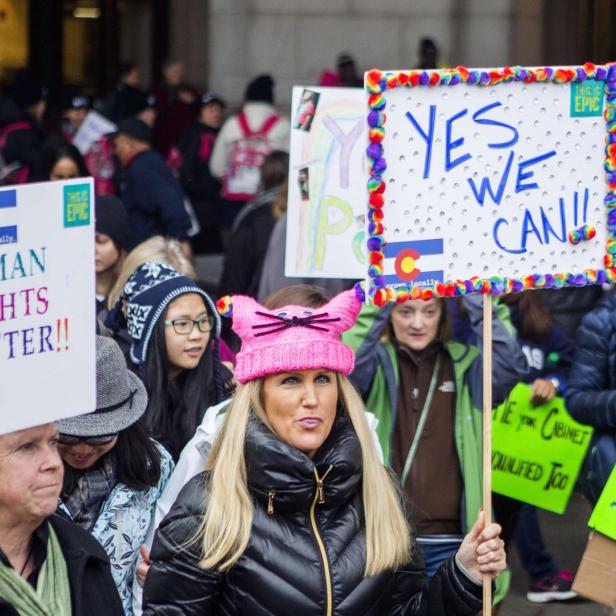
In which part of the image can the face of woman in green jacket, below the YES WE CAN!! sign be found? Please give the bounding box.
[391,299,443,351]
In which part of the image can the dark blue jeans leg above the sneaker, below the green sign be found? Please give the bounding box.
[514,504,558,581]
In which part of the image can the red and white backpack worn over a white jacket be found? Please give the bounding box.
[222,113,280,201]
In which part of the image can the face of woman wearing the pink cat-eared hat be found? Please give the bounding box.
[262,369,338,457]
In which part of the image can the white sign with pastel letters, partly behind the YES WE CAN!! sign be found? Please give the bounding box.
[285,86,366,279]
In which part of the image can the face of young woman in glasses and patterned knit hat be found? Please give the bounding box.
[165,293,210,378]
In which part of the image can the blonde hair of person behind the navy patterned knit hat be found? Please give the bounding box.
[107,235,197,308]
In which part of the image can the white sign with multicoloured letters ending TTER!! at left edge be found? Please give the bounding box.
[0,178,96,434]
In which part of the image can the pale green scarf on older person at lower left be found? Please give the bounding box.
[0,524,72,616]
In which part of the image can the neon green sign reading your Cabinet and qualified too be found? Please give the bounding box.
[492,383,592,513]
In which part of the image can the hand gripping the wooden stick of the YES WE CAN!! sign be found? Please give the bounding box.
[456,511,507,582]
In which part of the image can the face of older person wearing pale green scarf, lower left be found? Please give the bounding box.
[0,423,64,523]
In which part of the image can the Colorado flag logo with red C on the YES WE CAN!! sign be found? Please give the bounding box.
[383,239,443,286]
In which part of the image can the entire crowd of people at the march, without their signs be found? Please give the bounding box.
[0,45,616,616]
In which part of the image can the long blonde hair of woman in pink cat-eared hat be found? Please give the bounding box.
[195,374,411,576]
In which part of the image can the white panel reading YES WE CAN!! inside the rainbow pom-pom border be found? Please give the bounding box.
[383,82,606,286]
